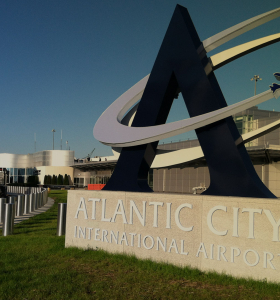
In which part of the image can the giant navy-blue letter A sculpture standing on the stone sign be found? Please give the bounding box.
[100,5,275,198]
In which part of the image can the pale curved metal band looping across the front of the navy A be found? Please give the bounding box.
[94,76,280,147]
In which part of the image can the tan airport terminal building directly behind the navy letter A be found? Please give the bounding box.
[153,107,280,197]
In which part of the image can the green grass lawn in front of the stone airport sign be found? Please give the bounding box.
[0,191,280,300]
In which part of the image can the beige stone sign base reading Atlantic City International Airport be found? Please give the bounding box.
[65,190,280,282]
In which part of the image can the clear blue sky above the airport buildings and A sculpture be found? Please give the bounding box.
[0,0,280,158]
